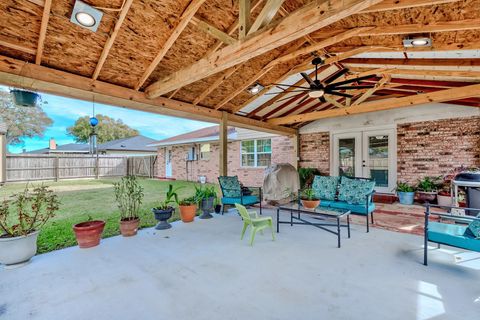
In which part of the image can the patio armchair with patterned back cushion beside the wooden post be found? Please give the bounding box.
[218,176,262,214]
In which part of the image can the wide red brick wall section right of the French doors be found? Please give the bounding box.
[397,117,480,183]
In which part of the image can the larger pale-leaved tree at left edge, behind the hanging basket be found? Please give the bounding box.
[0,91,53,145]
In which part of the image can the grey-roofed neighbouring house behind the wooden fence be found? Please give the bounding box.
[26,136,157,156]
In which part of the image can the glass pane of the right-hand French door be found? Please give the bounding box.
[368,136,388,187]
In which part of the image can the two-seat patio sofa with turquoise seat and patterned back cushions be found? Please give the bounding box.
[312,176,375,232]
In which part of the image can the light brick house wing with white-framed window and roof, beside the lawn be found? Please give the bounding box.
[152,126,296,186]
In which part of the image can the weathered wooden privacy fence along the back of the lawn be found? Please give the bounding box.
[6,154,156,182]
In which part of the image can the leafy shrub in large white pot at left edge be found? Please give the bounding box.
[0,186,60,268]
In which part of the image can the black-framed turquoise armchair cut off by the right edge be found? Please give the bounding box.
[423,203,480,265]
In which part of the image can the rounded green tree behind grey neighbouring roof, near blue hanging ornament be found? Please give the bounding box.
[67,114,139,143]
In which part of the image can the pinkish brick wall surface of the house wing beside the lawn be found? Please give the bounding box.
[156,137,295,186]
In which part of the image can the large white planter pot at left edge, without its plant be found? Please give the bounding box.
[0,231,40,268]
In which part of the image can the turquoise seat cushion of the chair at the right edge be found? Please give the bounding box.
[427,222,480,252]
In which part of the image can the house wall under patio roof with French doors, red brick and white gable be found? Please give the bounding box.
[299,103,480,193]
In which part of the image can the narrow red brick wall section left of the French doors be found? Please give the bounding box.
[299,132,330,174]
